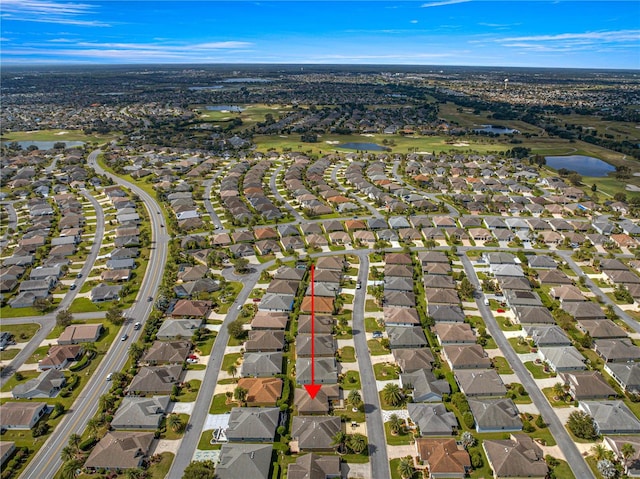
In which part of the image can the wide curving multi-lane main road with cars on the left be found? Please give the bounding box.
[20,150,169,479]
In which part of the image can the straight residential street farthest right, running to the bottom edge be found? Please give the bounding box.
[460,253,594,479]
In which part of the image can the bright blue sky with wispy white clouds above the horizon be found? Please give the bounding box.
[0,0,640,69]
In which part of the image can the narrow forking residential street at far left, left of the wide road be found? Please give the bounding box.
[0,189,104,387]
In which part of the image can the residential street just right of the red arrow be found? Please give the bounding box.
[352,251,391,479]
